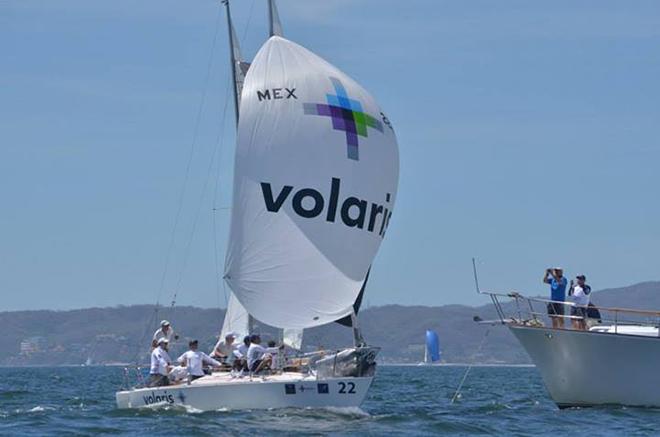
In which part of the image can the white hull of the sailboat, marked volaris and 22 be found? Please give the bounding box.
[116,373,373,411]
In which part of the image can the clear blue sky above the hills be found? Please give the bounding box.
[0,0,660,311]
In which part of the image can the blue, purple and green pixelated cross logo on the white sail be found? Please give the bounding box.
[303,77,383,161]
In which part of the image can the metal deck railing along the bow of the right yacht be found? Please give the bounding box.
[482,291,660,336]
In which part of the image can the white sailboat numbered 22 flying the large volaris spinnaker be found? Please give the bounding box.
[116,0,399,411]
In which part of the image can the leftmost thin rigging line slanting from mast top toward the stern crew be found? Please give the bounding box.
[156,4,222,306]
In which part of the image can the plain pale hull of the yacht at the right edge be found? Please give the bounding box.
[508,325,660,408]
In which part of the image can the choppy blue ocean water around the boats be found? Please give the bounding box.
[0,366,660,436]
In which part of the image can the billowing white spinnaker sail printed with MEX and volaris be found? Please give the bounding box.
[225,36,399,328]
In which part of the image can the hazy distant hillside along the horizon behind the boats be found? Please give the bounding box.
[0,282,660,365]
